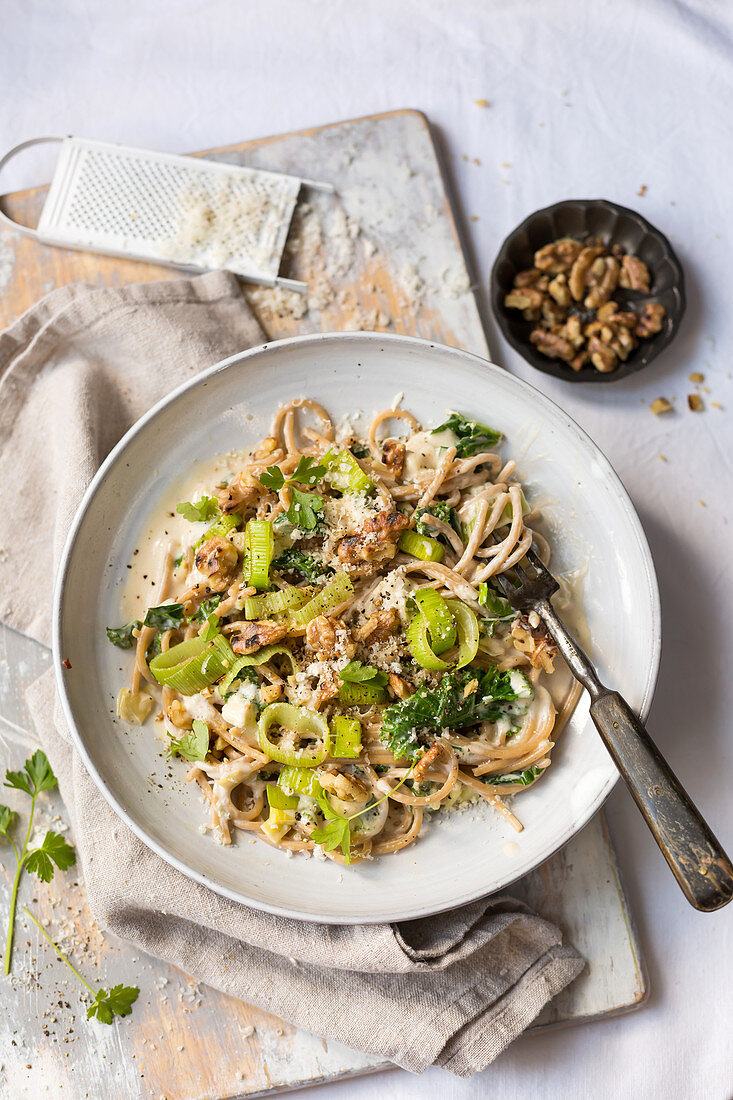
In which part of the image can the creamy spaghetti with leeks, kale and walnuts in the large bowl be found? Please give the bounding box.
[107,398,579,864]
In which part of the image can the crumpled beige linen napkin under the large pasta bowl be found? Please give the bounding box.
[0,273,583,1077]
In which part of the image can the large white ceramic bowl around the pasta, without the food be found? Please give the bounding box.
[54,333,660,923]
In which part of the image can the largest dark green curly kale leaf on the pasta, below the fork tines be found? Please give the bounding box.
[381,666,532,760]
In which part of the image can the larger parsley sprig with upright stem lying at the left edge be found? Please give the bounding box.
[0,749,76,974]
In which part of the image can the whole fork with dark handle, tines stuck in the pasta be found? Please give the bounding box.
[492,548,733,913]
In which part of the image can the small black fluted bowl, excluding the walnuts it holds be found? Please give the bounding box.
[491,199,686,382]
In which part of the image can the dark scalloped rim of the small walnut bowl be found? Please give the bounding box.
[489,199,687,384]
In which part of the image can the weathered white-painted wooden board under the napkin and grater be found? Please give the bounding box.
[0,111,646,1100]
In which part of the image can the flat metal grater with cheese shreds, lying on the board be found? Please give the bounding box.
[0,138,333,292]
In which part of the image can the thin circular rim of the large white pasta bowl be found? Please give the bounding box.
[52,332,661,925]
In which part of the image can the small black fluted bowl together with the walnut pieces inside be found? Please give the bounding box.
[492,199,685,382]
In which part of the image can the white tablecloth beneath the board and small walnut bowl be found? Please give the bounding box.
[0,0,733,1100]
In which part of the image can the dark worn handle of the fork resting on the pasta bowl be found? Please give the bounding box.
[590,688,733,913]
